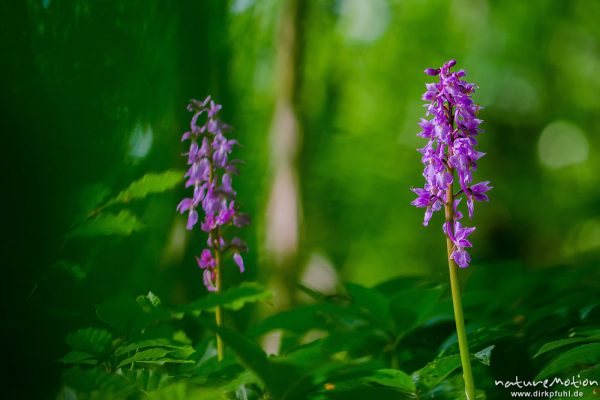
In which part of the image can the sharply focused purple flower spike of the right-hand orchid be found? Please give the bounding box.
[411,60,492,268]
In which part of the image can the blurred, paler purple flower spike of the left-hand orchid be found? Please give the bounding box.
[177,96,250,291]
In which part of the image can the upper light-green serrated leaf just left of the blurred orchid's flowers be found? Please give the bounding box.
[102,170,184,208]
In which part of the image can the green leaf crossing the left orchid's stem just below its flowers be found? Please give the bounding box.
[184,282,273,315]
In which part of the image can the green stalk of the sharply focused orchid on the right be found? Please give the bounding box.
[445,176,475,400]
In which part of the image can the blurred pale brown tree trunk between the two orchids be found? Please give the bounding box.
[265,0,305,310]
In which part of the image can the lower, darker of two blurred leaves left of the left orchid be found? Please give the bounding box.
[67,210,143,239]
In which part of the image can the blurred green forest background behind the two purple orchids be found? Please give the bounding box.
[0,0,600,398]
